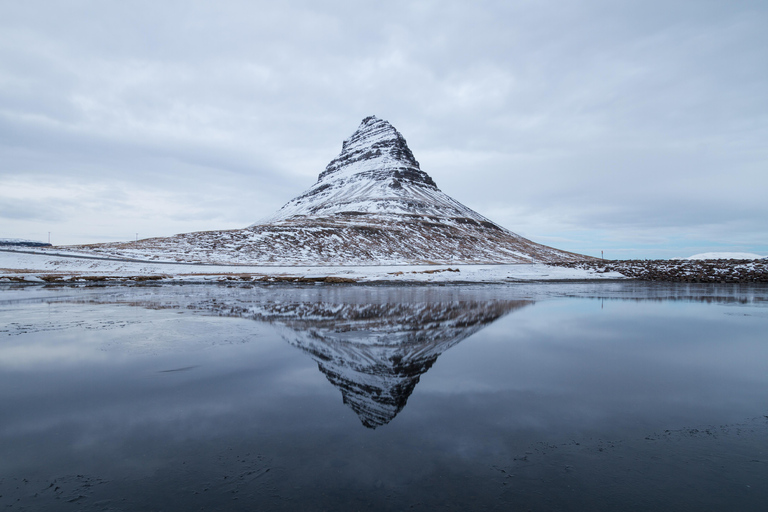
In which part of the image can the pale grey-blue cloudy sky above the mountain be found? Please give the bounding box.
[0,0,768,258]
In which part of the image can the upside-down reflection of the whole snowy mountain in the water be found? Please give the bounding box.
[73,290,533,428]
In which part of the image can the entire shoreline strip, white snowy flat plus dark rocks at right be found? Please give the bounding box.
[0,249,768,285]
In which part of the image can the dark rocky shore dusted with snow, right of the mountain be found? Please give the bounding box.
[550,258,768,283]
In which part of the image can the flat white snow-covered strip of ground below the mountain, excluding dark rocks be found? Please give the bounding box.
[0,250,626,283]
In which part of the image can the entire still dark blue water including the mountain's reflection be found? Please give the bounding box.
[0,283,768,511]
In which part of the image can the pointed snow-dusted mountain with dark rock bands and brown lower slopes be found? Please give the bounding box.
[74,116,587,265]
